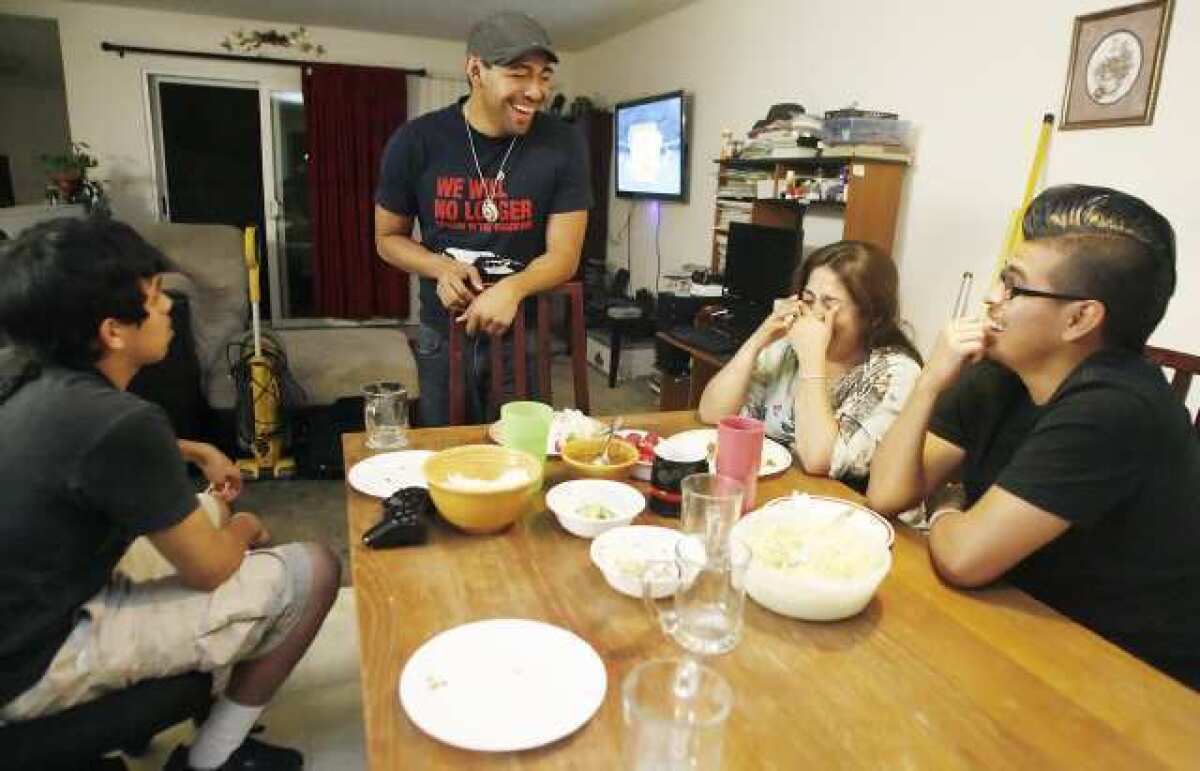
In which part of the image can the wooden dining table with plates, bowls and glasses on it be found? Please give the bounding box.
[342,412,1200,771]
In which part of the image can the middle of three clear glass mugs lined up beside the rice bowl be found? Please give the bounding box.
[642,534,750,656]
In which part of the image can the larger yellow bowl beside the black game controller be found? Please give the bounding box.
[425,444,541,533]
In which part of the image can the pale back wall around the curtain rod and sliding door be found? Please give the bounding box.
[4,0,580,219]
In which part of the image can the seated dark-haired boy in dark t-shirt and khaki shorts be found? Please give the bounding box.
[0,220,340,770]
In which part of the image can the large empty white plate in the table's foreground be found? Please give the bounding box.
[400,618,608,752]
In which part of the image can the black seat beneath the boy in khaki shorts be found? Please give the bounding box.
[0,673,212,771]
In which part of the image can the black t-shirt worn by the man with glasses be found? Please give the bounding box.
[930,351,1200,688]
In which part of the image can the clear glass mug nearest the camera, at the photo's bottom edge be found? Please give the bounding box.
[620,659,733,771]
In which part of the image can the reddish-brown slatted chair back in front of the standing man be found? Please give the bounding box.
[449,281,590,425]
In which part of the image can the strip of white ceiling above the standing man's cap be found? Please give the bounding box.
[63,0,694,50]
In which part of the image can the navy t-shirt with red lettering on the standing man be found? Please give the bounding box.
[376,101,592,327]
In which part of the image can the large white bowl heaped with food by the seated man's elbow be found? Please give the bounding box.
[733,495,894,621]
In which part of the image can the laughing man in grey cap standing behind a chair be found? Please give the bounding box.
[376,12,592,425]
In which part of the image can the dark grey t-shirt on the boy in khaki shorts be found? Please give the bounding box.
[0,367,197,705]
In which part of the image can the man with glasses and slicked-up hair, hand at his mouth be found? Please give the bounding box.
[868,185,1200,688]
